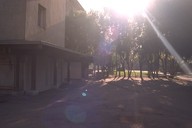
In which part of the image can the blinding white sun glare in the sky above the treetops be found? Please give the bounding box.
[79,0,152,16]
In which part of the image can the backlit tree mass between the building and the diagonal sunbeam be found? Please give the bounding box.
[66,9,190,78]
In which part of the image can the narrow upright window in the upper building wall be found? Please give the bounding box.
[38,4,46,29]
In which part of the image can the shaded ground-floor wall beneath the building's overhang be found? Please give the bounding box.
[0,49,85,94]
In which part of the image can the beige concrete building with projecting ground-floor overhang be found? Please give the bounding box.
[0,0,85,93]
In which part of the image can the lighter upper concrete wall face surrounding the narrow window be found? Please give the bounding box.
[25,0,66,47]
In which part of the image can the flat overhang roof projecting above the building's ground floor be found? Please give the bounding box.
[0,40,91,62]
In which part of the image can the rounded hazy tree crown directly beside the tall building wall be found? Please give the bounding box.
[66,12,100,55]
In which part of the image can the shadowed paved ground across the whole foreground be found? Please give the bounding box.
[0,79,192,128]
